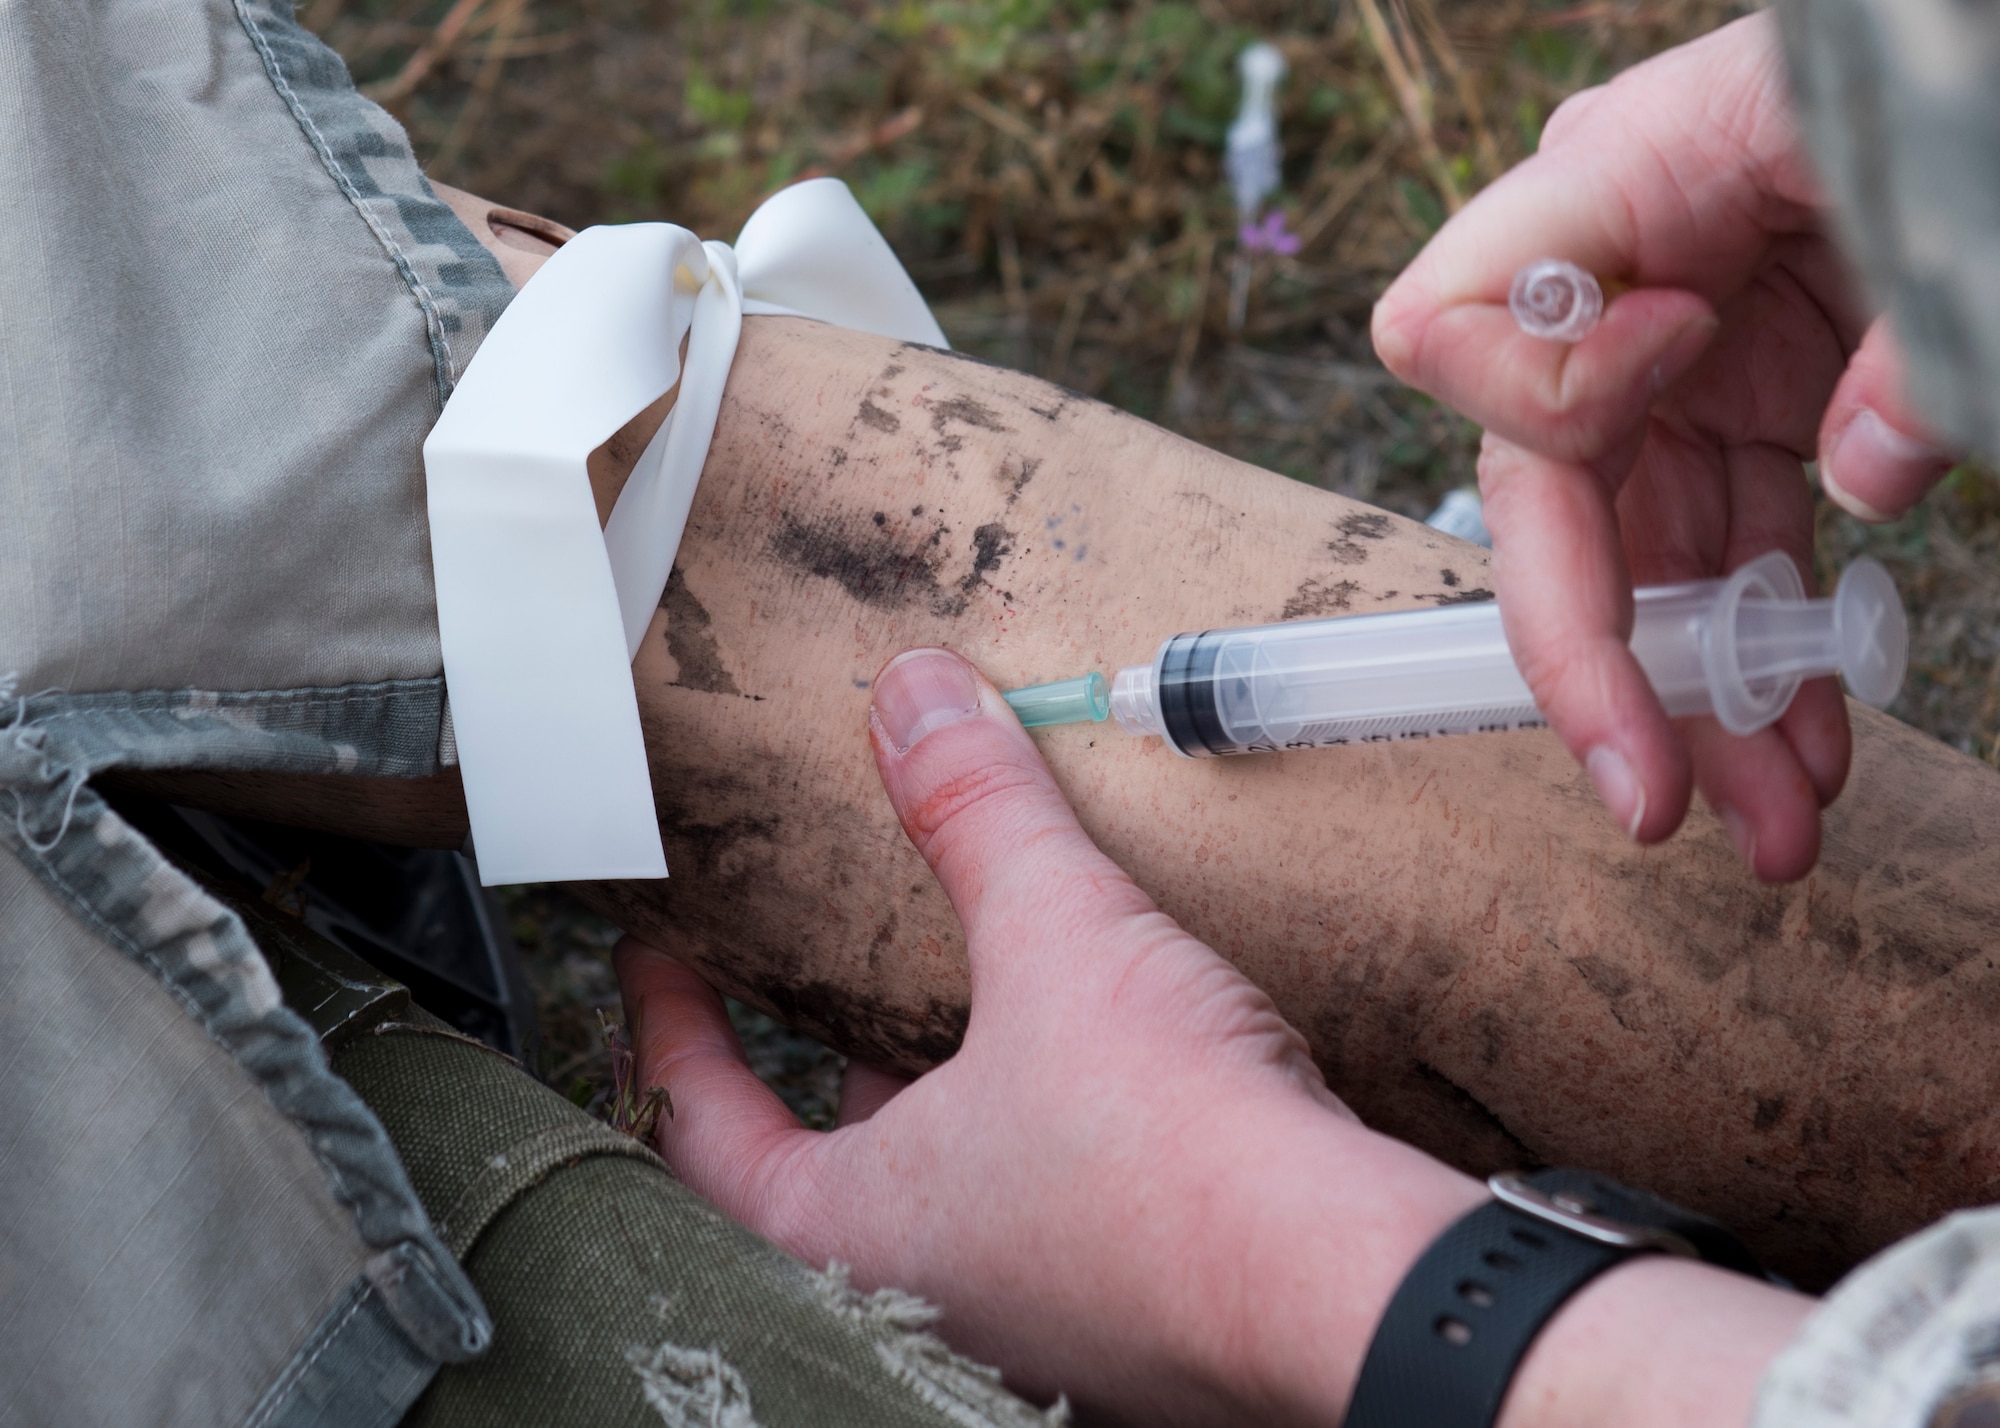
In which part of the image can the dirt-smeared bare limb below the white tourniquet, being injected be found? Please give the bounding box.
[568,318,2000,1284]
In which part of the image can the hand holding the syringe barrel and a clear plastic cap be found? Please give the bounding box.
[1374,16,1948,880]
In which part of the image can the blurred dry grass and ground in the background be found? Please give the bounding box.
[302,0,2000,1120]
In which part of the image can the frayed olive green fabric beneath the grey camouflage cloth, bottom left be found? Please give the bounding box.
[334,1012,1064,1428]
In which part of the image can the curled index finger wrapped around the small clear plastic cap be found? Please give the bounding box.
[1374,16,1812,460]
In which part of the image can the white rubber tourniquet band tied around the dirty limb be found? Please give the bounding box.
[424,178,946,884]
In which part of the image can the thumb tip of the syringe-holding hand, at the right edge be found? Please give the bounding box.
[1820,318,1952,520]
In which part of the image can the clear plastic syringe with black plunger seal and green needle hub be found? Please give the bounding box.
[1006,552,1910,758]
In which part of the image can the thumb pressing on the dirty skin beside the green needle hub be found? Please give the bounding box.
[868,650,1172,1008]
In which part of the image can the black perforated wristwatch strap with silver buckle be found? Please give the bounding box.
[1342,1170,1766,1428]
